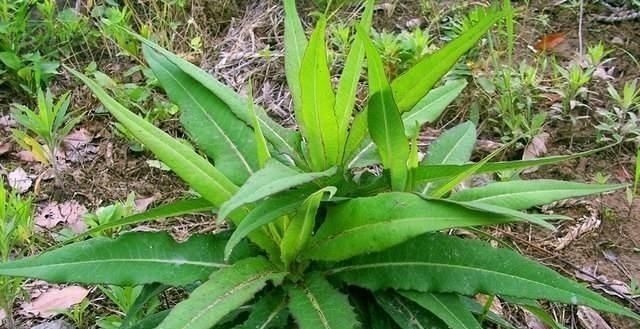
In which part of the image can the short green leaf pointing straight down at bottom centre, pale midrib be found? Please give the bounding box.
[289,273,358,329]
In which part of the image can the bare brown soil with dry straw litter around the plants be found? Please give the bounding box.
[0,1,640,329]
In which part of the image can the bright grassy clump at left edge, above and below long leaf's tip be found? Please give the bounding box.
[0,179,33,329]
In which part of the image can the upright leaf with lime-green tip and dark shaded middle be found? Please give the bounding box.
[358,30,409,191]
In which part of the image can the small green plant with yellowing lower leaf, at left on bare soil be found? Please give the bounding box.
[12,89,84,187]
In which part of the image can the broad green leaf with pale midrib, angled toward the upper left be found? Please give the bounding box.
[142,45,258,184]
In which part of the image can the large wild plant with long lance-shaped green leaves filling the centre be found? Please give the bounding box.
[0,0,640,329]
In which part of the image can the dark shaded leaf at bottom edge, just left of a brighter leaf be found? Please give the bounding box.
[376,292,447,329]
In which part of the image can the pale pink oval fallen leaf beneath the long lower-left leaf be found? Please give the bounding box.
[20,286,89,318]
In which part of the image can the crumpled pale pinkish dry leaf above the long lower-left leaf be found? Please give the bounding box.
[35,201,87,233]
